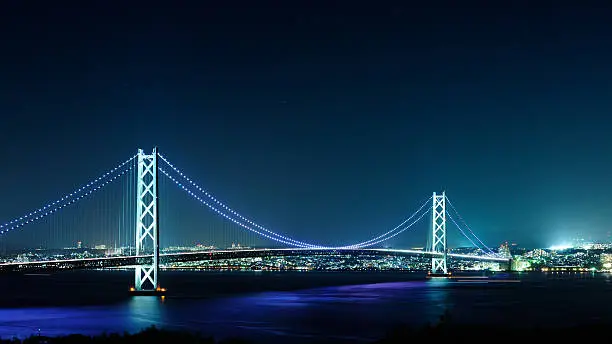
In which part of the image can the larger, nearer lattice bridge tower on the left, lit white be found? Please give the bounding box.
[131,147,165,294]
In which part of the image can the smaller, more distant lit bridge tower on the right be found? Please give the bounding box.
[431,191,448,275]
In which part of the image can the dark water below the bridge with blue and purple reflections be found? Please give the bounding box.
[0,271,612,343]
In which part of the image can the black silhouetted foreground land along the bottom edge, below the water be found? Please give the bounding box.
[0,323,612,344]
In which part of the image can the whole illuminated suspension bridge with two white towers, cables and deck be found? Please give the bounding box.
[0,148,510,293]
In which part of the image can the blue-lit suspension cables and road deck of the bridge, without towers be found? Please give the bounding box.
[0,148,502,291]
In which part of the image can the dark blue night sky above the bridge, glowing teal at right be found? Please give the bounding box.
[0,0,612,250]
